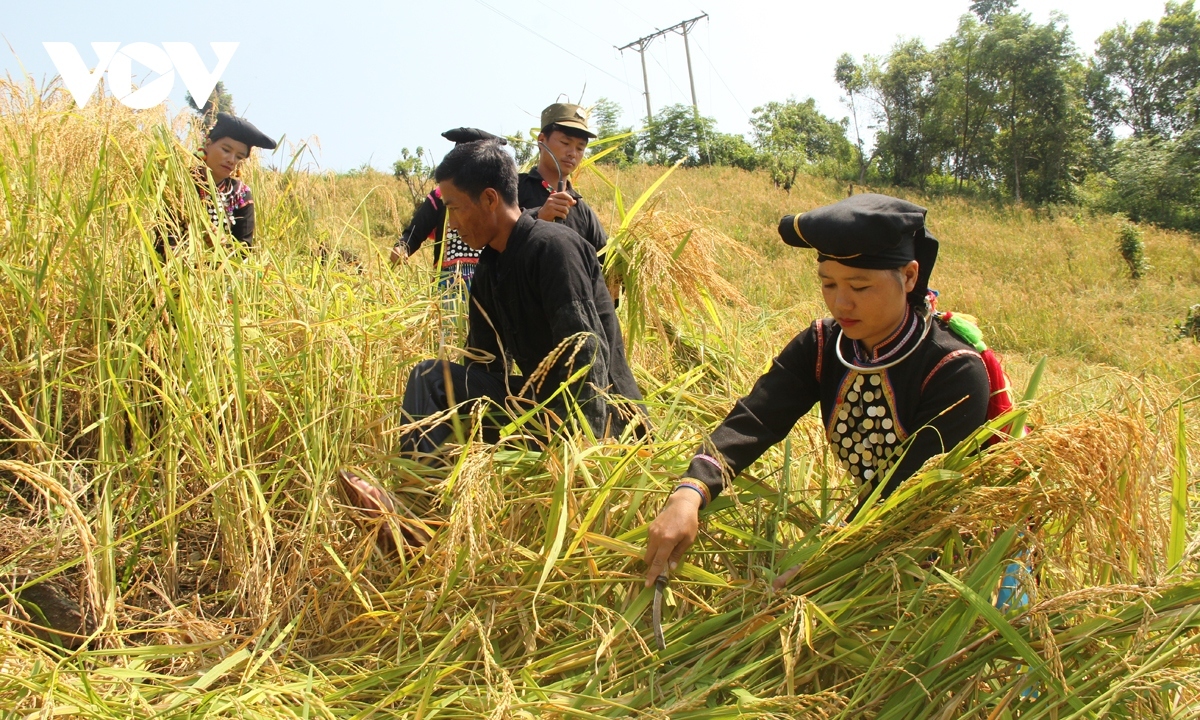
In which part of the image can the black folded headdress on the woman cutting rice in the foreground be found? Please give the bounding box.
[779,193,937,300]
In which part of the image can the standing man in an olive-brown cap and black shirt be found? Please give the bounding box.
[517,102,608,252]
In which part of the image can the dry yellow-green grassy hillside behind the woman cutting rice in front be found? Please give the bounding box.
[580,167,1200,386]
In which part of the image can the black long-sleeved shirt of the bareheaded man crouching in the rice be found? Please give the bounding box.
[467,214,644,437]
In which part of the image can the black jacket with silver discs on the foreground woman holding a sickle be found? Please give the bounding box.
[685,308,990,511]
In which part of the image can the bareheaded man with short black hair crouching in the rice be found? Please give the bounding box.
[401,140,644,452]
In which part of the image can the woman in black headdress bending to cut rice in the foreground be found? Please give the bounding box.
[646,194,991,586]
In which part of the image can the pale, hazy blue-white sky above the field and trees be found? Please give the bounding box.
[0,0,1163,170]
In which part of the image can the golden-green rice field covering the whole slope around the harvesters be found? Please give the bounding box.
[0,82,1200,720]
